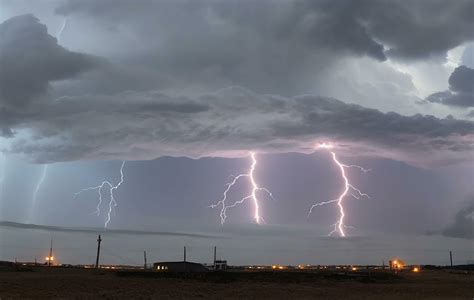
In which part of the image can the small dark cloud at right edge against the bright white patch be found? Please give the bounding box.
[426,66,474,107]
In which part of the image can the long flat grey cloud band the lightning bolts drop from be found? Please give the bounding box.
[0,87,474,164]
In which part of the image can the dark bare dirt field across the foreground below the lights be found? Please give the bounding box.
[0,268,474,300]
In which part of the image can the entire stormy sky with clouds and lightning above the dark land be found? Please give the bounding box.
[0,0,474,264]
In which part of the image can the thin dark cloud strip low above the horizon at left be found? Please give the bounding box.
[0,221,218,238]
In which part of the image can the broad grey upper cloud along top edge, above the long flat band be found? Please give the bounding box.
[50,0,474,96]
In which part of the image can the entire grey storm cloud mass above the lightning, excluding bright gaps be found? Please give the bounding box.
[0,5,474,164]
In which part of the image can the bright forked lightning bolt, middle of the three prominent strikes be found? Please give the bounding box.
[209,152,274,224]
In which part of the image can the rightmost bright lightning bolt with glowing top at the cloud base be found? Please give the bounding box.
[308,143,370,237]
